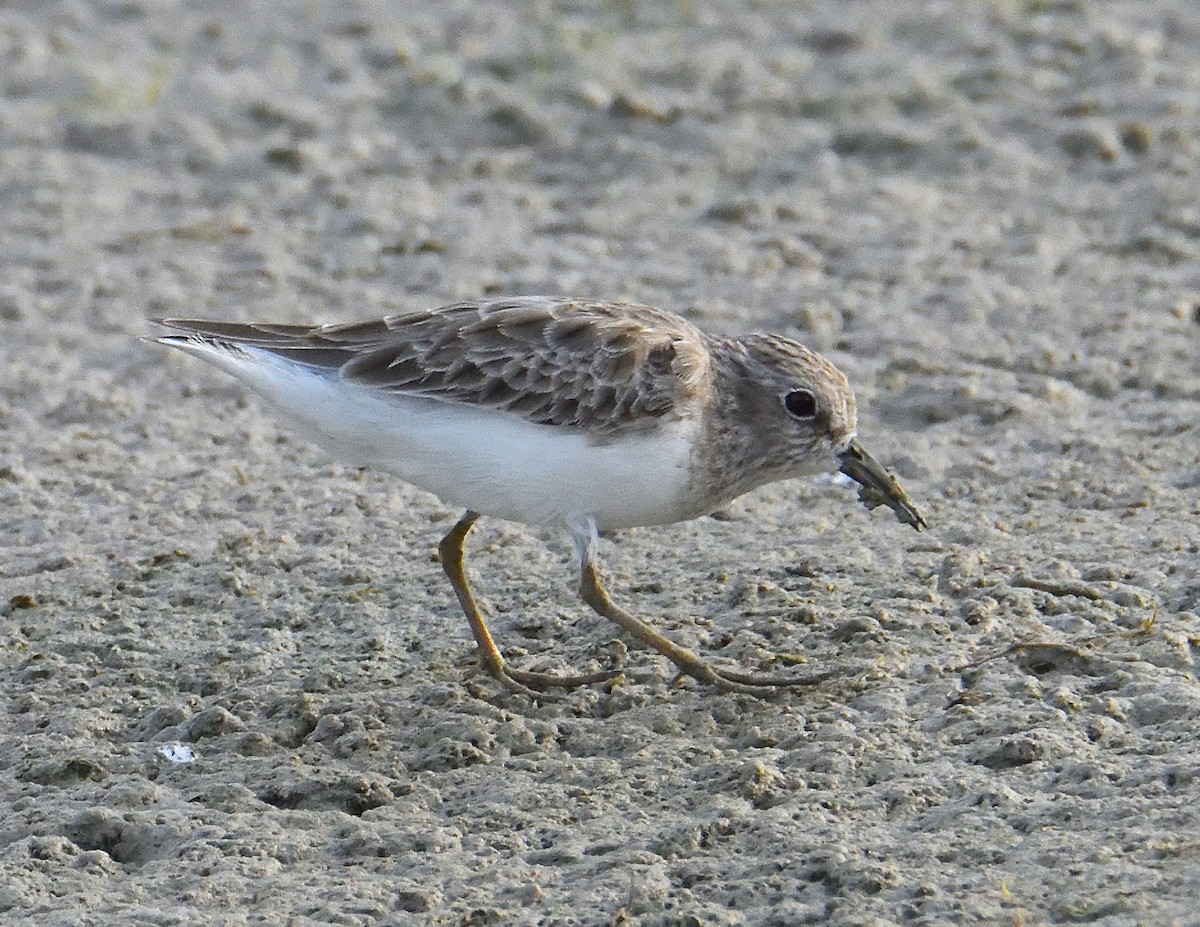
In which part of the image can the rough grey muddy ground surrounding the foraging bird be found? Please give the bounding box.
[0,0,1200,927]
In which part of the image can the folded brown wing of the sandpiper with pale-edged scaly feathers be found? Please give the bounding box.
[150,297,712,430]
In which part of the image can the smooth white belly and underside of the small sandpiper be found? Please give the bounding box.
[193,348,695,531]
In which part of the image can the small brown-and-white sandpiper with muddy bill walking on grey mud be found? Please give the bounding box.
[147,297,925,695]
